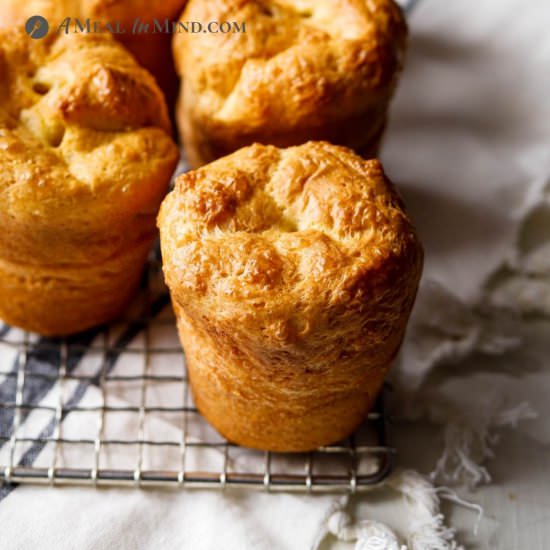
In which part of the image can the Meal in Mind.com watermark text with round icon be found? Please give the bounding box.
[25,15,246,39]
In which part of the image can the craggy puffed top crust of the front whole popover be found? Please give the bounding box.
[159,142,422,360]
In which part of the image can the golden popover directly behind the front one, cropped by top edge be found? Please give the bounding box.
[173,0,406,167]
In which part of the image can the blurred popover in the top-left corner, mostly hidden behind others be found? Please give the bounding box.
[0,0,186,105]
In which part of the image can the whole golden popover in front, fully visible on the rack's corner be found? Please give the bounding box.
[158,142,422,451]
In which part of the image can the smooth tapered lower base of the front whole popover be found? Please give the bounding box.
[176,307,389,452]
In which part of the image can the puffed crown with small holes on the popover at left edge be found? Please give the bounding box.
[0,31,178,264]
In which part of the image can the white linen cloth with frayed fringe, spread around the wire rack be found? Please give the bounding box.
[0,0,550,550]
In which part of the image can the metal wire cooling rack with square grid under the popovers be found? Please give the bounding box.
[0,259,394,492]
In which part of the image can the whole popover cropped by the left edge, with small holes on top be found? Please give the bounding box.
[0,31,178,335]
